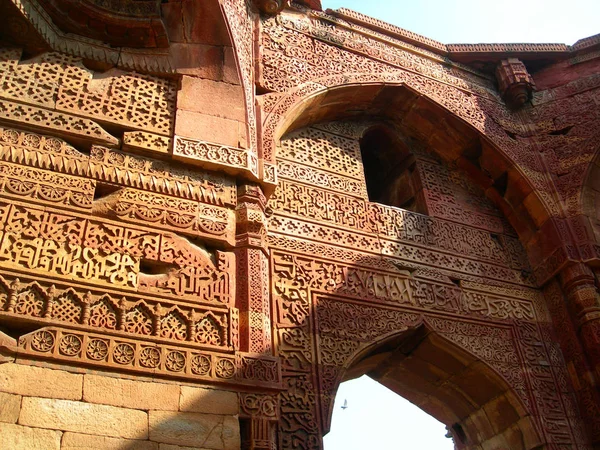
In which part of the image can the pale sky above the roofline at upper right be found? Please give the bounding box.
[321,0,600,45]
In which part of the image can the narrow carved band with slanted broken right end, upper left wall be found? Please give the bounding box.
[0,100,119,147]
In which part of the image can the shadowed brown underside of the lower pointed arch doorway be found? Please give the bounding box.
[329,324,542,450]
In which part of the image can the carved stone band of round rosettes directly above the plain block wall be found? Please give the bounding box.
[17,327,281,389]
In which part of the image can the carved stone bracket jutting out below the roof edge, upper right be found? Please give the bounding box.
[496,58,535,109]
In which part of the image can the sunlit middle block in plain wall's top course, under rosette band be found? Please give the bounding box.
[83,375,179,411]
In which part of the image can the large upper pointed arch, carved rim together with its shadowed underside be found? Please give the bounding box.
[262,77,574,283]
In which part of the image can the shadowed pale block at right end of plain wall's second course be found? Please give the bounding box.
[149,411,240,450]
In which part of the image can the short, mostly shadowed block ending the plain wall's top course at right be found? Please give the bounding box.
[179,386,238,415]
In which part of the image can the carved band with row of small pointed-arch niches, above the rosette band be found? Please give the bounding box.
[0,274,239,352]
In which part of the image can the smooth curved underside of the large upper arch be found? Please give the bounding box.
[270,81,564,277]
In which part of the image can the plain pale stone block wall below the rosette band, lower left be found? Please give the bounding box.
[0,363,240,450]
